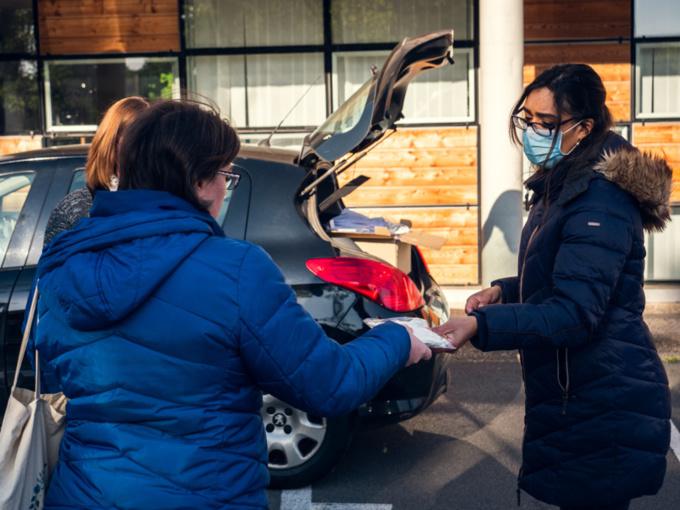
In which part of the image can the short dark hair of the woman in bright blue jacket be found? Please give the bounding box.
[118,100,241,210]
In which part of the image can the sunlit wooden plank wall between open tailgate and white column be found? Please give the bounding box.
[341,127,479,285]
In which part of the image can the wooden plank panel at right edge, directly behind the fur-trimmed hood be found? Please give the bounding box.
[633,122,680,205]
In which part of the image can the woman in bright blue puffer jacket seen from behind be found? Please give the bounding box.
[36,97,431,510]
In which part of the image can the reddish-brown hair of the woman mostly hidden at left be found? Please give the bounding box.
[85,96,149,190]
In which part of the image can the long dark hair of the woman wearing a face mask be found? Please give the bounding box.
[509,64,614,202]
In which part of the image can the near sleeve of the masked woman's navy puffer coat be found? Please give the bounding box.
[472,205,633,351]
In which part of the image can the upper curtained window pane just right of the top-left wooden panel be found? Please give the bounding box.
[184,0,323,48]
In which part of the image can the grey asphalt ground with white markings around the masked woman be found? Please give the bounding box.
[269,307,680,510]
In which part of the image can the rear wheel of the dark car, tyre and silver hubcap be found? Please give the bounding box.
[262,395,355,489]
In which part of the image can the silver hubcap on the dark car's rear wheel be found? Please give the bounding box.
[261,395,326,469]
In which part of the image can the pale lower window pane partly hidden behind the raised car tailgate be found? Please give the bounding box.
[333,49,475,124]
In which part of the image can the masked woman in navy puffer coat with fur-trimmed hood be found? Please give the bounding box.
[432,64,671,509]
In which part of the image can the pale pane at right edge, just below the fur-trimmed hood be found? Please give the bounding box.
[645,207,680,280]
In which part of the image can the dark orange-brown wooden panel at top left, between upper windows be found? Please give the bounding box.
[38,0,180,55]
